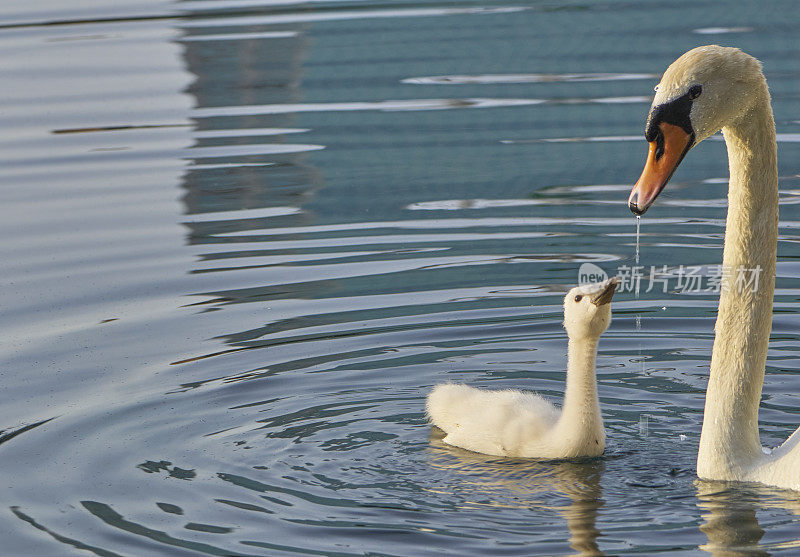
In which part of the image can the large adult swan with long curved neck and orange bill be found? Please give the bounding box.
[628,46,800,490]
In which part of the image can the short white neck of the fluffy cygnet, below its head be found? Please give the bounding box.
[556,337,604,436]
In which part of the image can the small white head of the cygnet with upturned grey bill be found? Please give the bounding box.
[564,277,619,339]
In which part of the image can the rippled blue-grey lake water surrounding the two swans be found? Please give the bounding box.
[0,0,800,556]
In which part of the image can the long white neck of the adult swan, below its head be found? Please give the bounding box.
[697,83,778,479]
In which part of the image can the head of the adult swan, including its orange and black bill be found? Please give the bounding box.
[628,45,769,215]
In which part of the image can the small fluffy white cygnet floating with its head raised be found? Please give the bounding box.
[427,278,618,459]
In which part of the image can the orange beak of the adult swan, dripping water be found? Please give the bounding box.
[628,122,693,215]
